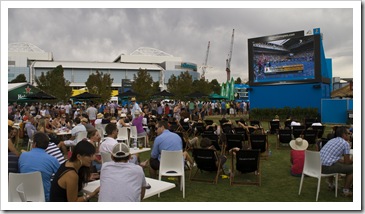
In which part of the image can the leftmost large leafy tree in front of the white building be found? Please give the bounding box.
[35,65,72,102]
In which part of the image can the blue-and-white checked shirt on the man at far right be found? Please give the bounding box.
[320,137,350,166]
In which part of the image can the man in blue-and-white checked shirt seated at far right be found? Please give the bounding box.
[320,126,353,196]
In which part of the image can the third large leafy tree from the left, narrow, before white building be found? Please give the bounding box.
[132,69,156,101]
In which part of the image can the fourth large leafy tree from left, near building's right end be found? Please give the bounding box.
[167,71,194,100]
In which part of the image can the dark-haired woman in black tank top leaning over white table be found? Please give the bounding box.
[50,139,99,202]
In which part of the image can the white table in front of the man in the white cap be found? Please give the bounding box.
[82,178,176,199]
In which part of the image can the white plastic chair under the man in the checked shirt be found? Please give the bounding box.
[298,150,338,201]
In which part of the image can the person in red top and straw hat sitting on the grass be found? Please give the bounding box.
[289,137,308,177]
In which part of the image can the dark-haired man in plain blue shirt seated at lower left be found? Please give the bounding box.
[19,132,60,201]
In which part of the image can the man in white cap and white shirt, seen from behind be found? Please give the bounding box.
[99,143,148,202]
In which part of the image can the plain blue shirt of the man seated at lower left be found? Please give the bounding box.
[19,148,60,201]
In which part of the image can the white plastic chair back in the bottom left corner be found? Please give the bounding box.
[8,171,46,202]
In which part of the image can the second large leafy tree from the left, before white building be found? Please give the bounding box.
[85,71,114,102]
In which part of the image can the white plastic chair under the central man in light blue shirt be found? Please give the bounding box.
[158,150,185,198]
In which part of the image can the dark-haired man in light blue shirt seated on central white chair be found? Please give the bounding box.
[150,120,182,179]
